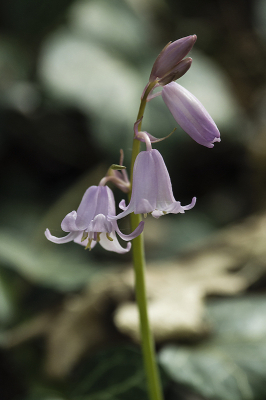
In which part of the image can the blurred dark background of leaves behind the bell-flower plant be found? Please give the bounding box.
[0,0,266,400]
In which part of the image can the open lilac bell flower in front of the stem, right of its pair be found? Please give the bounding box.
[112,149,196,219]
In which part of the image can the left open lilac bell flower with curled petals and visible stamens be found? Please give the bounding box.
[45,186,144,253]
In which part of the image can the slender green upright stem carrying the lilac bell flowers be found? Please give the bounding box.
[129,82,163,400]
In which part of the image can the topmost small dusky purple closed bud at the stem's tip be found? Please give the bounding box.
[149,35,197,82]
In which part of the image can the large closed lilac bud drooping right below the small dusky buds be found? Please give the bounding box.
[162,82,221,148]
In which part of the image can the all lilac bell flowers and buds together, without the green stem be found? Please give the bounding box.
[45,35,220,253]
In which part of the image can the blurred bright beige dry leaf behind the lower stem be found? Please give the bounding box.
[114,248,249,342]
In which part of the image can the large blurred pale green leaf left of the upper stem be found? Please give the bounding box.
[39,29,145,154]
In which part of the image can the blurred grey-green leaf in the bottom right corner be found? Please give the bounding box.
[160,297,266,400]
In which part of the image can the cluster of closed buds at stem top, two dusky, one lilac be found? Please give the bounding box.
[145,35,220,148]
